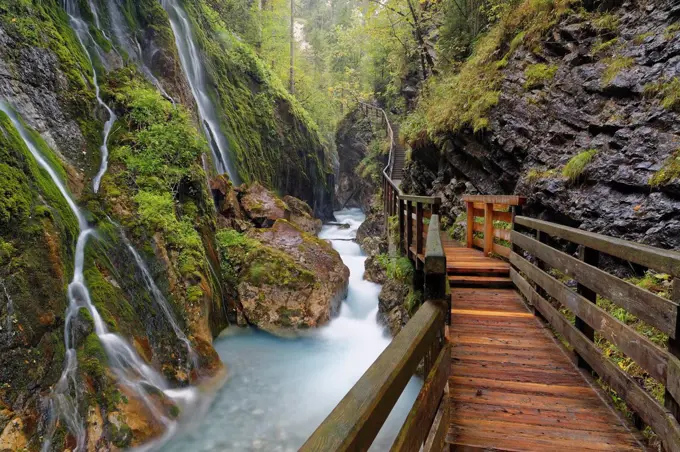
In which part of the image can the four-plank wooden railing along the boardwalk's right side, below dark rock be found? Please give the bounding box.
[510,216,680,451]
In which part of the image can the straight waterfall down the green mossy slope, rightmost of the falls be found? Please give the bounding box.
[161,0,241,185]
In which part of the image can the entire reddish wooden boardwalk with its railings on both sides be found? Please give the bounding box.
[301,106,680,451]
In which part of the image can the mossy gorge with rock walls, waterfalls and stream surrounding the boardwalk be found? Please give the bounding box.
[0,0,680,452]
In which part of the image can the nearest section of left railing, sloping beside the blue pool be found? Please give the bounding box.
[300,300,451,452]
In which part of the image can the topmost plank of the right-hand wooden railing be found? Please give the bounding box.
[515,217,680,276]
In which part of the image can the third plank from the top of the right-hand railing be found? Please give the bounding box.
[510,260,668,382]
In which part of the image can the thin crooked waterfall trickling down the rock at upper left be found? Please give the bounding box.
[64,0,118,193]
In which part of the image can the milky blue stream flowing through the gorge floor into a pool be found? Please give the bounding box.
[163,209,421,452]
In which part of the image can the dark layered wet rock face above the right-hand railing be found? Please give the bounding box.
[410,0,680,248]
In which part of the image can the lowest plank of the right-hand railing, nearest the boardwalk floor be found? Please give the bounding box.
[520,276,680,451]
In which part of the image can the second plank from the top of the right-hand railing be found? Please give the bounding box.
[512,231,678,337]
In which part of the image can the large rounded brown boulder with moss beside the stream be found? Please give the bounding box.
[217,220,349,336]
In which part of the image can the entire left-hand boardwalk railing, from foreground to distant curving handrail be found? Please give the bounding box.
[301,103,451,452]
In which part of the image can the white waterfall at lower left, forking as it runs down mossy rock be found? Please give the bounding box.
[0,102,196,451]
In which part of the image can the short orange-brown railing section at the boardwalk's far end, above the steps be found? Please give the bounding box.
[463,195,526,258]
